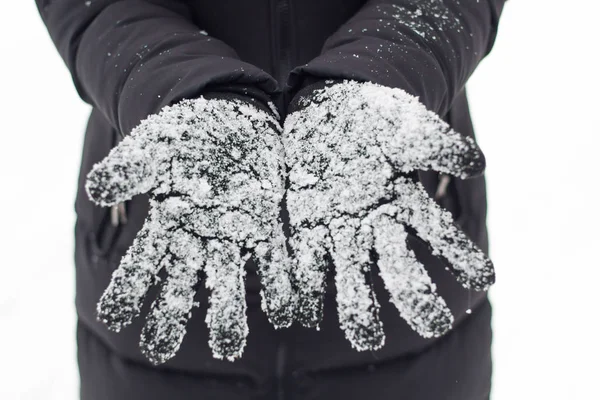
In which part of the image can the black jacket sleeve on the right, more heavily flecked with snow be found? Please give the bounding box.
[288,0,505,115]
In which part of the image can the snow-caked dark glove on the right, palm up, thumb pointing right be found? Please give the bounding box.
[284,81,494,350]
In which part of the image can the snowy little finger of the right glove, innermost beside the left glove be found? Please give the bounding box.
[290,226,328,327]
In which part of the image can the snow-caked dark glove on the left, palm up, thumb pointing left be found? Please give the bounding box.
[86,95,294,364]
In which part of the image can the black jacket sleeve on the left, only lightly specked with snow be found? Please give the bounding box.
[36,0,277,134]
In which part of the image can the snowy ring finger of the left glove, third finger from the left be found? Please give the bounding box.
[205,240,248,361]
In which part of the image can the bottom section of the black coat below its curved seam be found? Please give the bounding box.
[77,301,492,400]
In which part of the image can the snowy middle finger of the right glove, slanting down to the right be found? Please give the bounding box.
[374,215,454,338]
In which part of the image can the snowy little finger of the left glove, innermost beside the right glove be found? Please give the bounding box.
[255,224,295,328]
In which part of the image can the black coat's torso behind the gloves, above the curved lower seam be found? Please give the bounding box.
[76,0,487,379]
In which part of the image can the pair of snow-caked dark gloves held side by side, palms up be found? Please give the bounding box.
[86,81,494,364]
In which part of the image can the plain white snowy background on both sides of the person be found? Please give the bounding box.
[0,0,600,400]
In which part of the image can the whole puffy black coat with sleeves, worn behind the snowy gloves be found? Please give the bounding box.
[36,0,504,400]
